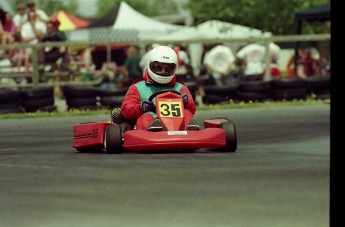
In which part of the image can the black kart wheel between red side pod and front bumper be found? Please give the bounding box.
[104,124,123,154]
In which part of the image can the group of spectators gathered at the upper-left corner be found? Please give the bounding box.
[0,1,67,83]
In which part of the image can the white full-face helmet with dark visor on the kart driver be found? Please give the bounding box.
[147,46,177,84]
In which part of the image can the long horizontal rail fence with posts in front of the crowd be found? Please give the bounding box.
[0,33,331,87]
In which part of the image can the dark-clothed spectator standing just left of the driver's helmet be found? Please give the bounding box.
[124,46,143,85]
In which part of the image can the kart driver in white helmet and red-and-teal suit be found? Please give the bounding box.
[121,46,199,131]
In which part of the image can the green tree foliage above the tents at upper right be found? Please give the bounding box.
[186,0,329,35]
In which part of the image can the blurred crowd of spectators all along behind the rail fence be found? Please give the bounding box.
[0,1,330,89]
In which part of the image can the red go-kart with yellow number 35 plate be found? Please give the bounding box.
[72,91,237,153]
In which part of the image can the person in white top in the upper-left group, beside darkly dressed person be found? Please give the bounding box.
[20,10,47,73]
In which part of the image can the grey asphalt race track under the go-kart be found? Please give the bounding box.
[0,104,330,227]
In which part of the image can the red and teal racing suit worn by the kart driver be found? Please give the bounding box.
[121,69,196,130]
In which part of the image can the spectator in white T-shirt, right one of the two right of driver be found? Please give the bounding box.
[237,39,266,81]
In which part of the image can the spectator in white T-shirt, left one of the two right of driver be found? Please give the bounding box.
[203,44,237,85]
